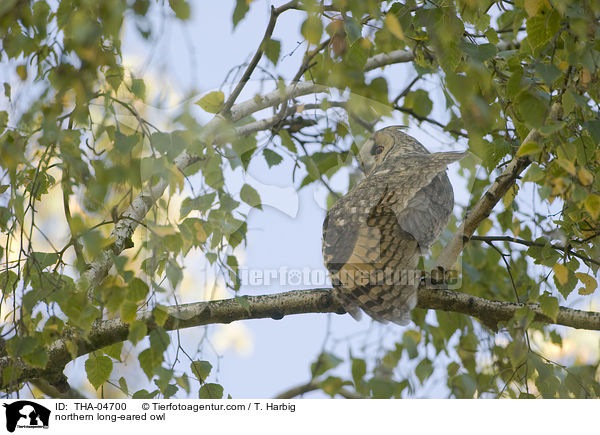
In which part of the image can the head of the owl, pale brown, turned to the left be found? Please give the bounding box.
[358,125,429,174]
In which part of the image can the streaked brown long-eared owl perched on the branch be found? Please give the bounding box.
[323,126,466,325]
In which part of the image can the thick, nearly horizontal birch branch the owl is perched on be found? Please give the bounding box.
[0,288,600,387]
